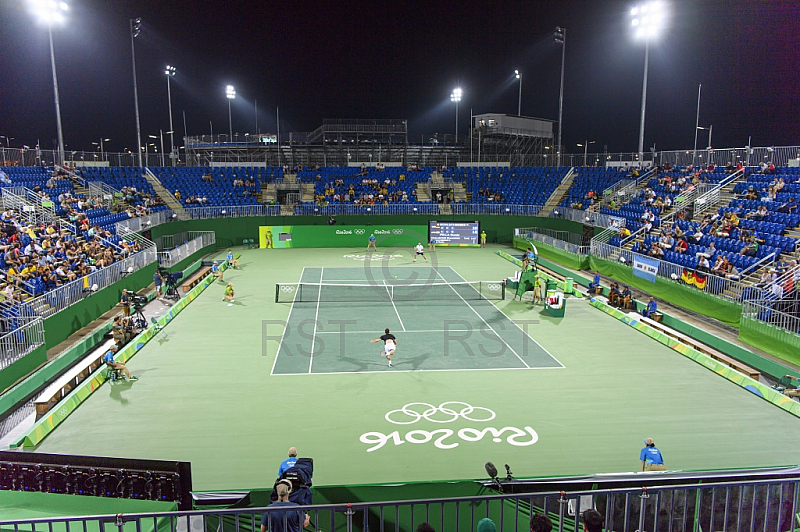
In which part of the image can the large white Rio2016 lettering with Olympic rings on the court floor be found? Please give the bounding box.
[359,401,539,453]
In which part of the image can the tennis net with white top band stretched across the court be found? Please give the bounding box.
[275,281,506,303]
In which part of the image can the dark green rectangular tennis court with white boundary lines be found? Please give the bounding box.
[272,263,564,375]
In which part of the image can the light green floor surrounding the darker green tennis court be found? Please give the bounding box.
[31,246,800,490]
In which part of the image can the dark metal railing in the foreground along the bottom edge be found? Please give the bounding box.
[0,478,798,532]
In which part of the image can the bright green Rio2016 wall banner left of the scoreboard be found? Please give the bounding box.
[258,224,428,250]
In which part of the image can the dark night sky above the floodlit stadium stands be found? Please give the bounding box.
[0,0,800,156]
